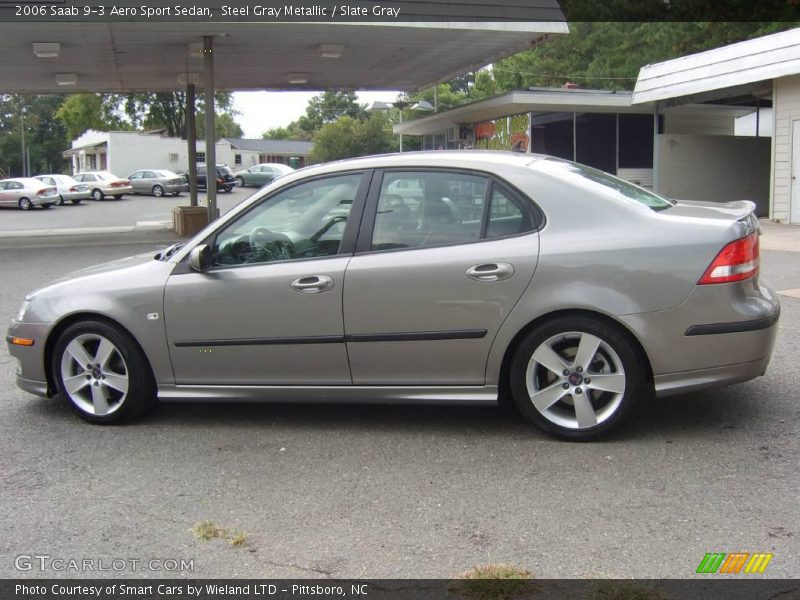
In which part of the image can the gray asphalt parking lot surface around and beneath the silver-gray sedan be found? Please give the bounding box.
[0,229,800,578]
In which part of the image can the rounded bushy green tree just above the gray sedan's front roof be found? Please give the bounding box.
[310,113,396,162]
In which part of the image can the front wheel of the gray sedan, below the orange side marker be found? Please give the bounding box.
[51,320,156,424]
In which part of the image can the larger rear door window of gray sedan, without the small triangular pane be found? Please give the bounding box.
[371,171,488,250]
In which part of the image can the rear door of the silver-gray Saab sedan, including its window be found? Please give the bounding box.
[344,169,541,385]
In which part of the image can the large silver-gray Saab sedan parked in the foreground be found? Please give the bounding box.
[8,151,780,440]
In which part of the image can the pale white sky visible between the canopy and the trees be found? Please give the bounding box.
[233,92,398,139]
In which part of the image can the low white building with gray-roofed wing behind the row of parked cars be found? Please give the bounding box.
[64,129,313,177]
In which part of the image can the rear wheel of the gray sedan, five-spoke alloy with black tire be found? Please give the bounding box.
[510,316,651,442]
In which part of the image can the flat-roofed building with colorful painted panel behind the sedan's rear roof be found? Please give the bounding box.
[395,86,770,215]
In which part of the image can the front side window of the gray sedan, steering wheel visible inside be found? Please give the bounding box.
[212,174,362,267]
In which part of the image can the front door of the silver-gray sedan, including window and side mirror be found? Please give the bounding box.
[164,173,368,385]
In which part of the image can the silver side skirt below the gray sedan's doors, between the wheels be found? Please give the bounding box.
[158,385,497,405]
